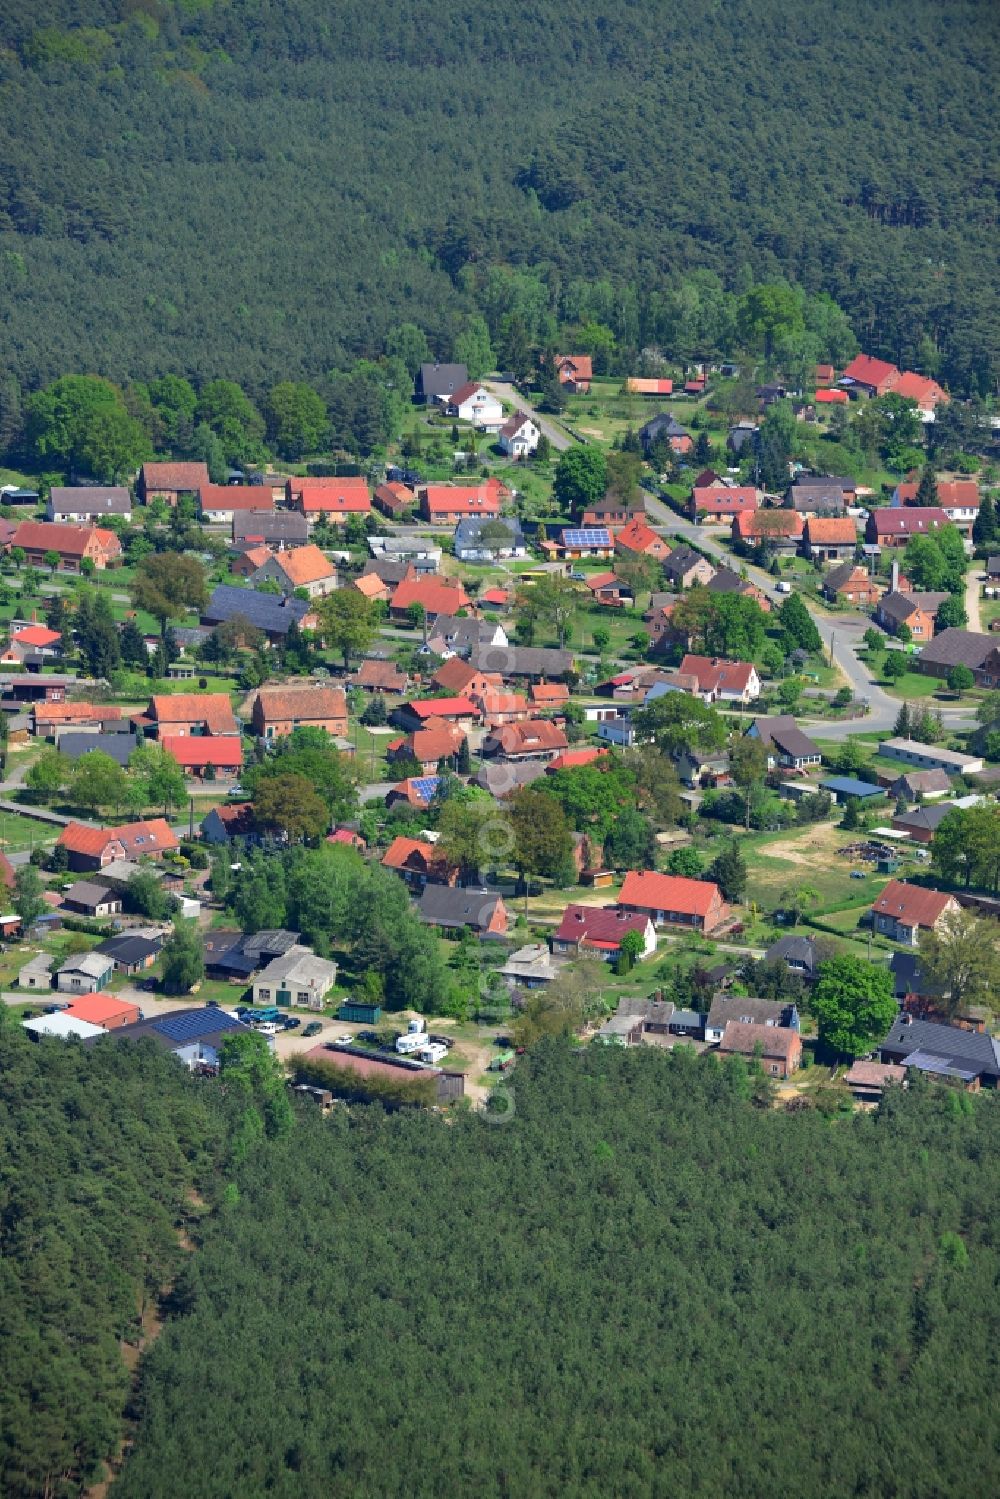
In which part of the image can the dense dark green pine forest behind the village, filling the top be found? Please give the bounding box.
[0,0,1000,403]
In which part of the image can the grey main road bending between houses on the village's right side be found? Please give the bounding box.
[645,492,978,739]
